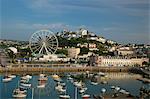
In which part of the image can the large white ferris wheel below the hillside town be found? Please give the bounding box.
[29,30,58,55]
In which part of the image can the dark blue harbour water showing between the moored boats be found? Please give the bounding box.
[0,74,149,99]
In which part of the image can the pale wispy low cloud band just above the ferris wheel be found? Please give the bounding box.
[2,22,87,32]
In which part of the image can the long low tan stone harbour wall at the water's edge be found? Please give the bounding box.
[0,66,131,73]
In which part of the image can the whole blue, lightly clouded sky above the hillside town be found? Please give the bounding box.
[0,0,150,44]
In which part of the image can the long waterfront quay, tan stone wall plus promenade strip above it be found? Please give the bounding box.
[0,64,131,73]
